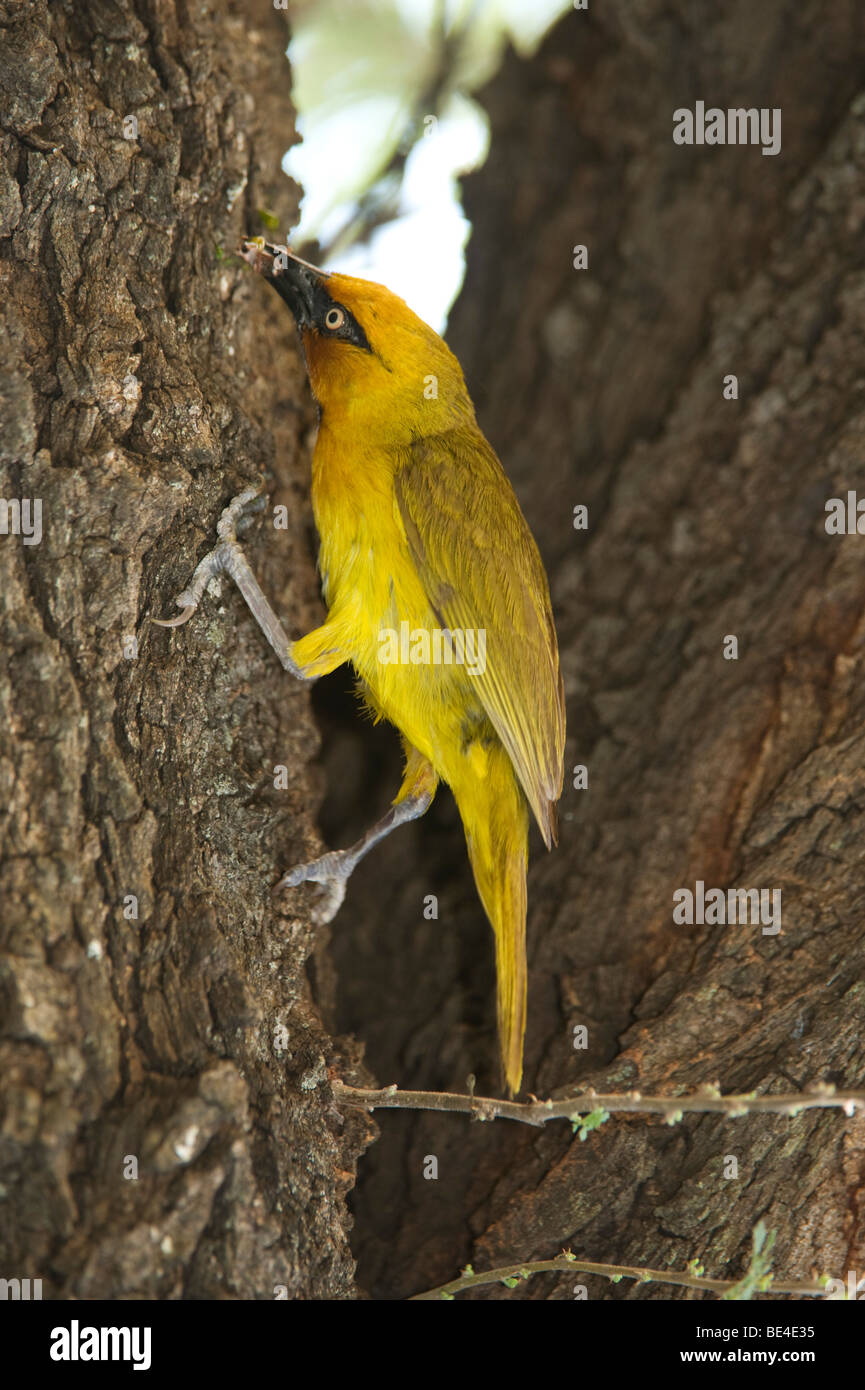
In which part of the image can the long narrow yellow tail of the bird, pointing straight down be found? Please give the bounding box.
[452,746,528,1095]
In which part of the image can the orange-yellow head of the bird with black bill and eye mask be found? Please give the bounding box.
[242,239,474,446]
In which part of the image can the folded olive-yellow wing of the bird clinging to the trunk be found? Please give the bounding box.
[395,430,565,847]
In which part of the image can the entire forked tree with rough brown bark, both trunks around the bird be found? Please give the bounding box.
[0,0,865,1298]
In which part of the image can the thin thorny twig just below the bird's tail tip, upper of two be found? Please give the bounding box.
[332,1081,865,1125]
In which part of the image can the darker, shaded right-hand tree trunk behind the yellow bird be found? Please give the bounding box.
[337,0,865,1300]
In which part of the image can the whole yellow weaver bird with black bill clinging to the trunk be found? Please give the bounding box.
[159,239,565,1094]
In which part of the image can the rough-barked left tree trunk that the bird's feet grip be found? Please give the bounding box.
[0,0,370,1298]
